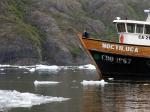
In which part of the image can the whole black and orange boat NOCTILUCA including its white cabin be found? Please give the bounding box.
[78,10,150,78]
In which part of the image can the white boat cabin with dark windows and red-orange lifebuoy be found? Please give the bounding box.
[113,10,150,46]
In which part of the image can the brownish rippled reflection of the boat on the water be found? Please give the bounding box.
[84,81,150,112]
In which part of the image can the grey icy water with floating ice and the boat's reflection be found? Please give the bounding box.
[0,66,150,112]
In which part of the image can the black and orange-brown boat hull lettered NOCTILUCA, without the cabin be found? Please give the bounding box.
[78,33,150,78]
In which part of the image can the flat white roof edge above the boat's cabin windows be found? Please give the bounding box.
[113,20,150,25]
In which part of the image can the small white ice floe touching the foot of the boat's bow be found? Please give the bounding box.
[81,80,108,86]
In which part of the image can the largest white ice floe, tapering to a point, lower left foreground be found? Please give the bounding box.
[0,90,69,111]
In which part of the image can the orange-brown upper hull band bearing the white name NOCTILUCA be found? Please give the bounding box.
[82,38,150,58]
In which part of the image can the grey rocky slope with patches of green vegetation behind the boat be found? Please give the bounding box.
[0,0,150,65]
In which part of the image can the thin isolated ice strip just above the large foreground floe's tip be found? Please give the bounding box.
[34,80,60,86]
